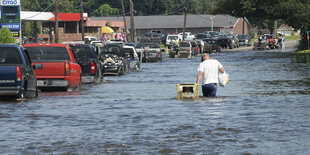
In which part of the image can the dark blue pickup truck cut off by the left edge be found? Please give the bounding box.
[0,44,42,98]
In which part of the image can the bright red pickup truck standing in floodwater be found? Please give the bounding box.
[24,44,81,91]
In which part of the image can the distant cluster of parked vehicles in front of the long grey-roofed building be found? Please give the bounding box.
[152,31,252,58]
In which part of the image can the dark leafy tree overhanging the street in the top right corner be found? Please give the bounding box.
[213,0,310,49]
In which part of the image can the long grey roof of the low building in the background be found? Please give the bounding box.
[89,15,238,29]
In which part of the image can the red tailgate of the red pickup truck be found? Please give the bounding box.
[33,61,65,78]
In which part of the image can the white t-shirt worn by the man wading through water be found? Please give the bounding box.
[198,59,223,85]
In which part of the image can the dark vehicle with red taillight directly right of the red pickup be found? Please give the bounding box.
[69,44,103,84]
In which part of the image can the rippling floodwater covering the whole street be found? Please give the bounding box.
[0,47,310,155]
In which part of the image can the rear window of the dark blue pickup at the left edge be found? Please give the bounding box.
[0,47,23,64]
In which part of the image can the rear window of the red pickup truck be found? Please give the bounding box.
[27,47,70,61]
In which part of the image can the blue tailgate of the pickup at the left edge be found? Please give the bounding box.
[0,66,16,87]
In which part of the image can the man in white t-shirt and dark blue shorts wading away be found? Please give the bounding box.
[196,53,224,97]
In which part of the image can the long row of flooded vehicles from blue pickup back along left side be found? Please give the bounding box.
[0,40,162,98]
